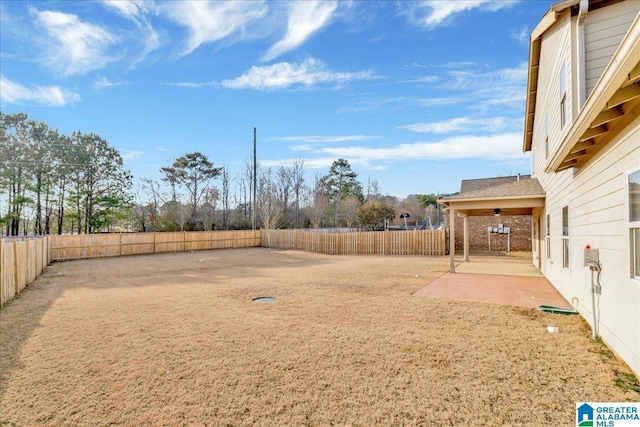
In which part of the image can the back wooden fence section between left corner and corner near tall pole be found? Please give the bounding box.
[50,230,260,261]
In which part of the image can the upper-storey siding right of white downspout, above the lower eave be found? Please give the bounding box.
[584,0,640,97]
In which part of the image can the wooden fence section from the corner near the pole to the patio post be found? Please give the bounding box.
[261,230,446,255]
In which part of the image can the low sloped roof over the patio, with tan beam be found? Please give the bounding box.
[438,178,545,216]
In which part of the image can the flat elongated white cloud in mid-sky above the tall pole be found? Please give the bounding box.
[221,58,374,90]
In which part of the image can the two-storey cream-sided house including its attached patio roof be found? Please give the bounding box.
[441,0,640,373]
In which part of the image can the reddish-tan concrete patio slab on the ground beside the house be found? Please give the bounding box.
[413,270,571,308]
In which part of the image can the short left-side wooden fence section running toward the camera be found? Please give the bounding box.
[0,236,51,306]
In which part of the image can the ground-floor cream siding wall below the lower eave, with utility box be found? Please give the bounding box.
[543,118,640,378]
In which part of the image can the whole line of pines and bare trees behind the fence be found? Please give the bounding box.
[0,112,450,236]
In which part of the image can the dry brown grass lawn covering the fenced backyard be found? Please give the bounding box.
[0,249,638,426]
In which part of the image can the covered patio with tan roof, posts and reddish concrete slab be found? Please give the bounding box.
[414,178,571,308]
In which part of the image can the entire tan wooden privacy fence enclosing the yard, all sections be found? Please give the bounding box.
[0,230,446,306]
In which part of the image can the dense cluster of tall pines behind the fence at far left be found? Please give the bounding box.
[0,112,133,236]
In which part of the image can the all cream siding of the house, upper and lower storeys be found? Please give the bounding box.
[531,0,640,382]
